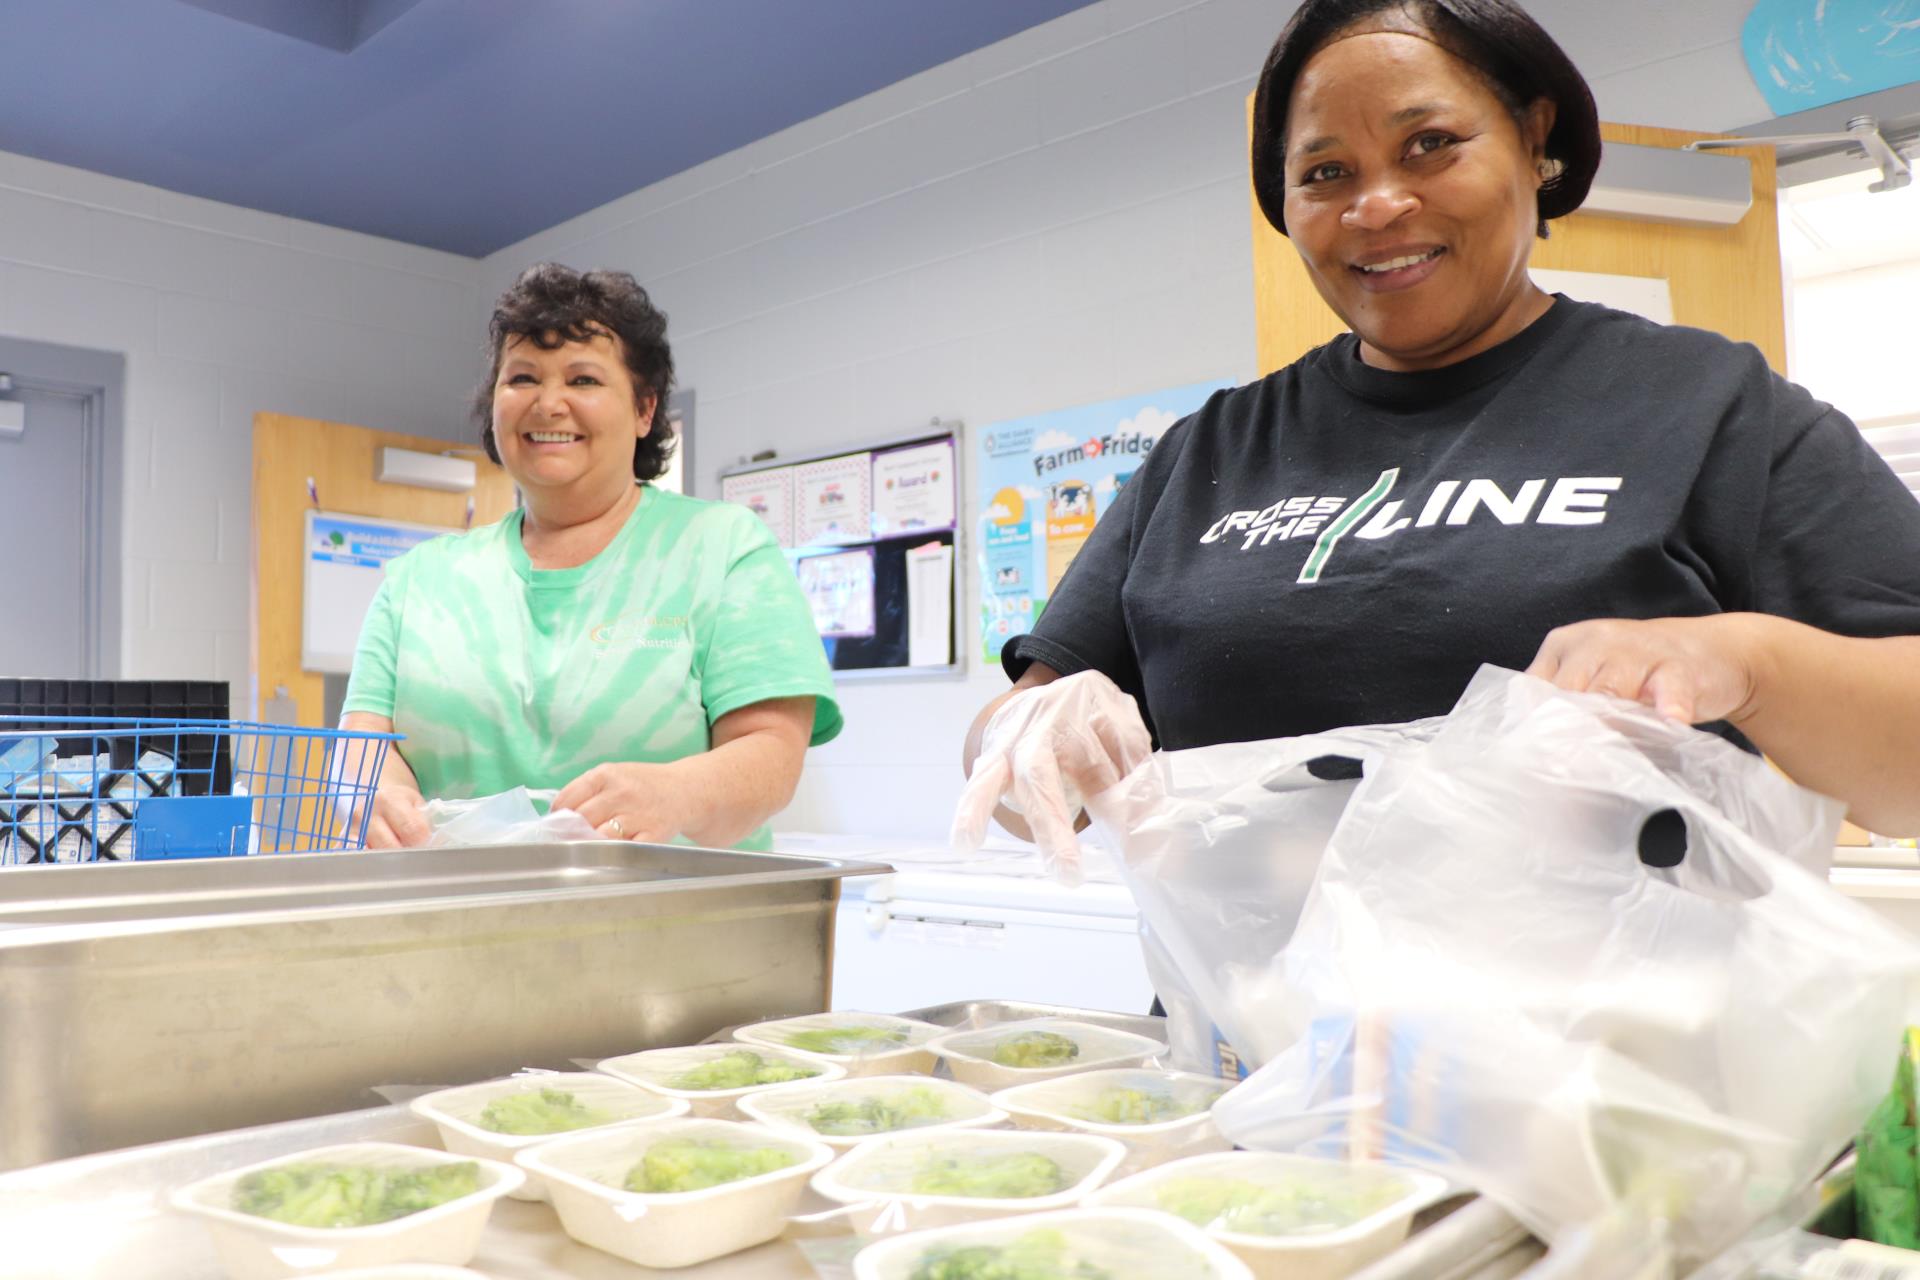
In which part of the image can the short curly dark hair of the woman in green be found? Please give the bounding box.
[474,263,674,480]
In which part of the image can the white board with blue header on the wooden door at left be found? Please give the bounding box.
[300,509,459,676]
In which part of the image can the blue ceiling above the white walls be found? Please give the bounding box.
[0,0,1089,257]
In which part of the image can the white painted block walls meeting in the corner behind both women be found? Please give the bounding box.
[0,0,1797,821]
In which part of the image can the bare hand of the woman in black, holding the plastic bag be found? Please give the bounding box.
[1526,614,1764,723]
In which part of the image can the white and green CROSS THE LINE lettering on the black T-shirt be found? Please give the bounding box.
[1200,466,1620,583]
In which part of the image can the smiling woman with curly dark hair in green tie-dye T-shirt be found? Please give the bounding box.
[342,265,841,848]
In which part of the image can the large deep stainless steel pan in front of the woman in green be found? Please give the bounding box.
[0,842,887,1169]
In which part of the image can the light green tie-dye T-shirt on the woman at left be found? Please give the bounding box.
[344,486,841,848]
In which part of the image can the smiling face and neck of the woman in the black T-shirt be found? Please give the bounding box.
[1286,27,1553,370]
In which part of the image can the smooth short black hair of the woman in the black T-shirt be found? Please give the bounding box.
[1252,0,1599,236]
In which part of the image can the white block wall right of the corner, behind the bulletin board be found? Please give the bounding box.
[480,0,1789,839]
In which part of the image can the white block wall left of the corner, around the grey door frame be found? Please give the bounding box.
[0,152,484,714]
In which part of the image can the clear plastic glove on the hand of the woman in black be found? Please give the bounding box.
[950,672,1154,885]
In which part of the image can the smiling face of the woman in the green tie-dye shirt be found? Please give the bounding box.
[493,332,653,495]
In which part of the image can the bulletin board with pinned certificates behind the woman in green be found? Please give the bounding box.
[720,422,962,677]
